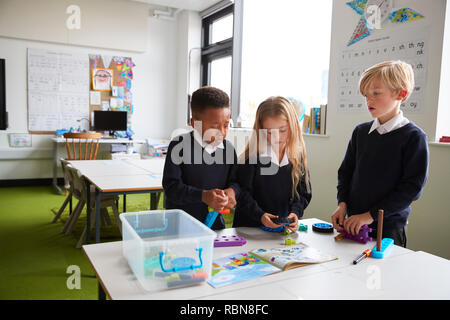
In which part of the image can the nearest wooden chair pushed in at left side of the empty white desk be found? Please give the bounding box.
[62,164,122,248]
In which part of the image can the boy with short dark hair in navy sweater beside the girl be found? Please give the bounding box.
[163,87,239,230]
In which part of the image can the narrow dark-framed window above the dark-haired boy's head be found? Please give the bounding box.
[201,5,234,97]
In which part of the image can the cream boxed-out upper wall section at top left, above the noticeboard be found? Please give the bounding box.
[0,0,149,52]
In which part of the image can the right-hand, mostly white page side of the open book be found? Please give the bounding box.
[250,243,337,271]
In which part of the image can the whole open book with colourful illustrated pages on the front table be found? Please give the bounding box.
[208,243,337,288]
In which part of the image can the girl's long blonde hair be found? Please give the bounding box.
[240,96,309,199]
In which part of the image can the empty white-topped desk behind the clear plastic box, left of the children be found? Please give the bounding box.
[68,158,165,243]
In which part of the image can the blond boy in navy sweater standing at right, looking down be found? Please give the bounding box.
[331,61,429,247]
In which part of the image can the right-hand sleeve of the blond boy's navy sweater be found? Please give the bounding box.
[370,133,429,220]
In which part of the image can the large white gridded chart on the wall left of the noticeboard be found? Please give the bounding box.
[28,48,89,132]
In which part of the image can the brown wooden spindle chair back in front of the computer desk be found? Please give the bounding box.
[64,132,102,160]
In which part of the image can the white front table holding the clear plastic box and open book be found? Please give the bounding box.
[83,219,450,300]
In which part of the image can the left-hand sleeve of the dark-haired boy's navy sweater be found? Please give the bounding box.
[162,136,202,205]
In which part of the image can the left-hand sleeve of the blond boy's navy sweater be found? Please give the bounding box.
[337,128,358,204]
